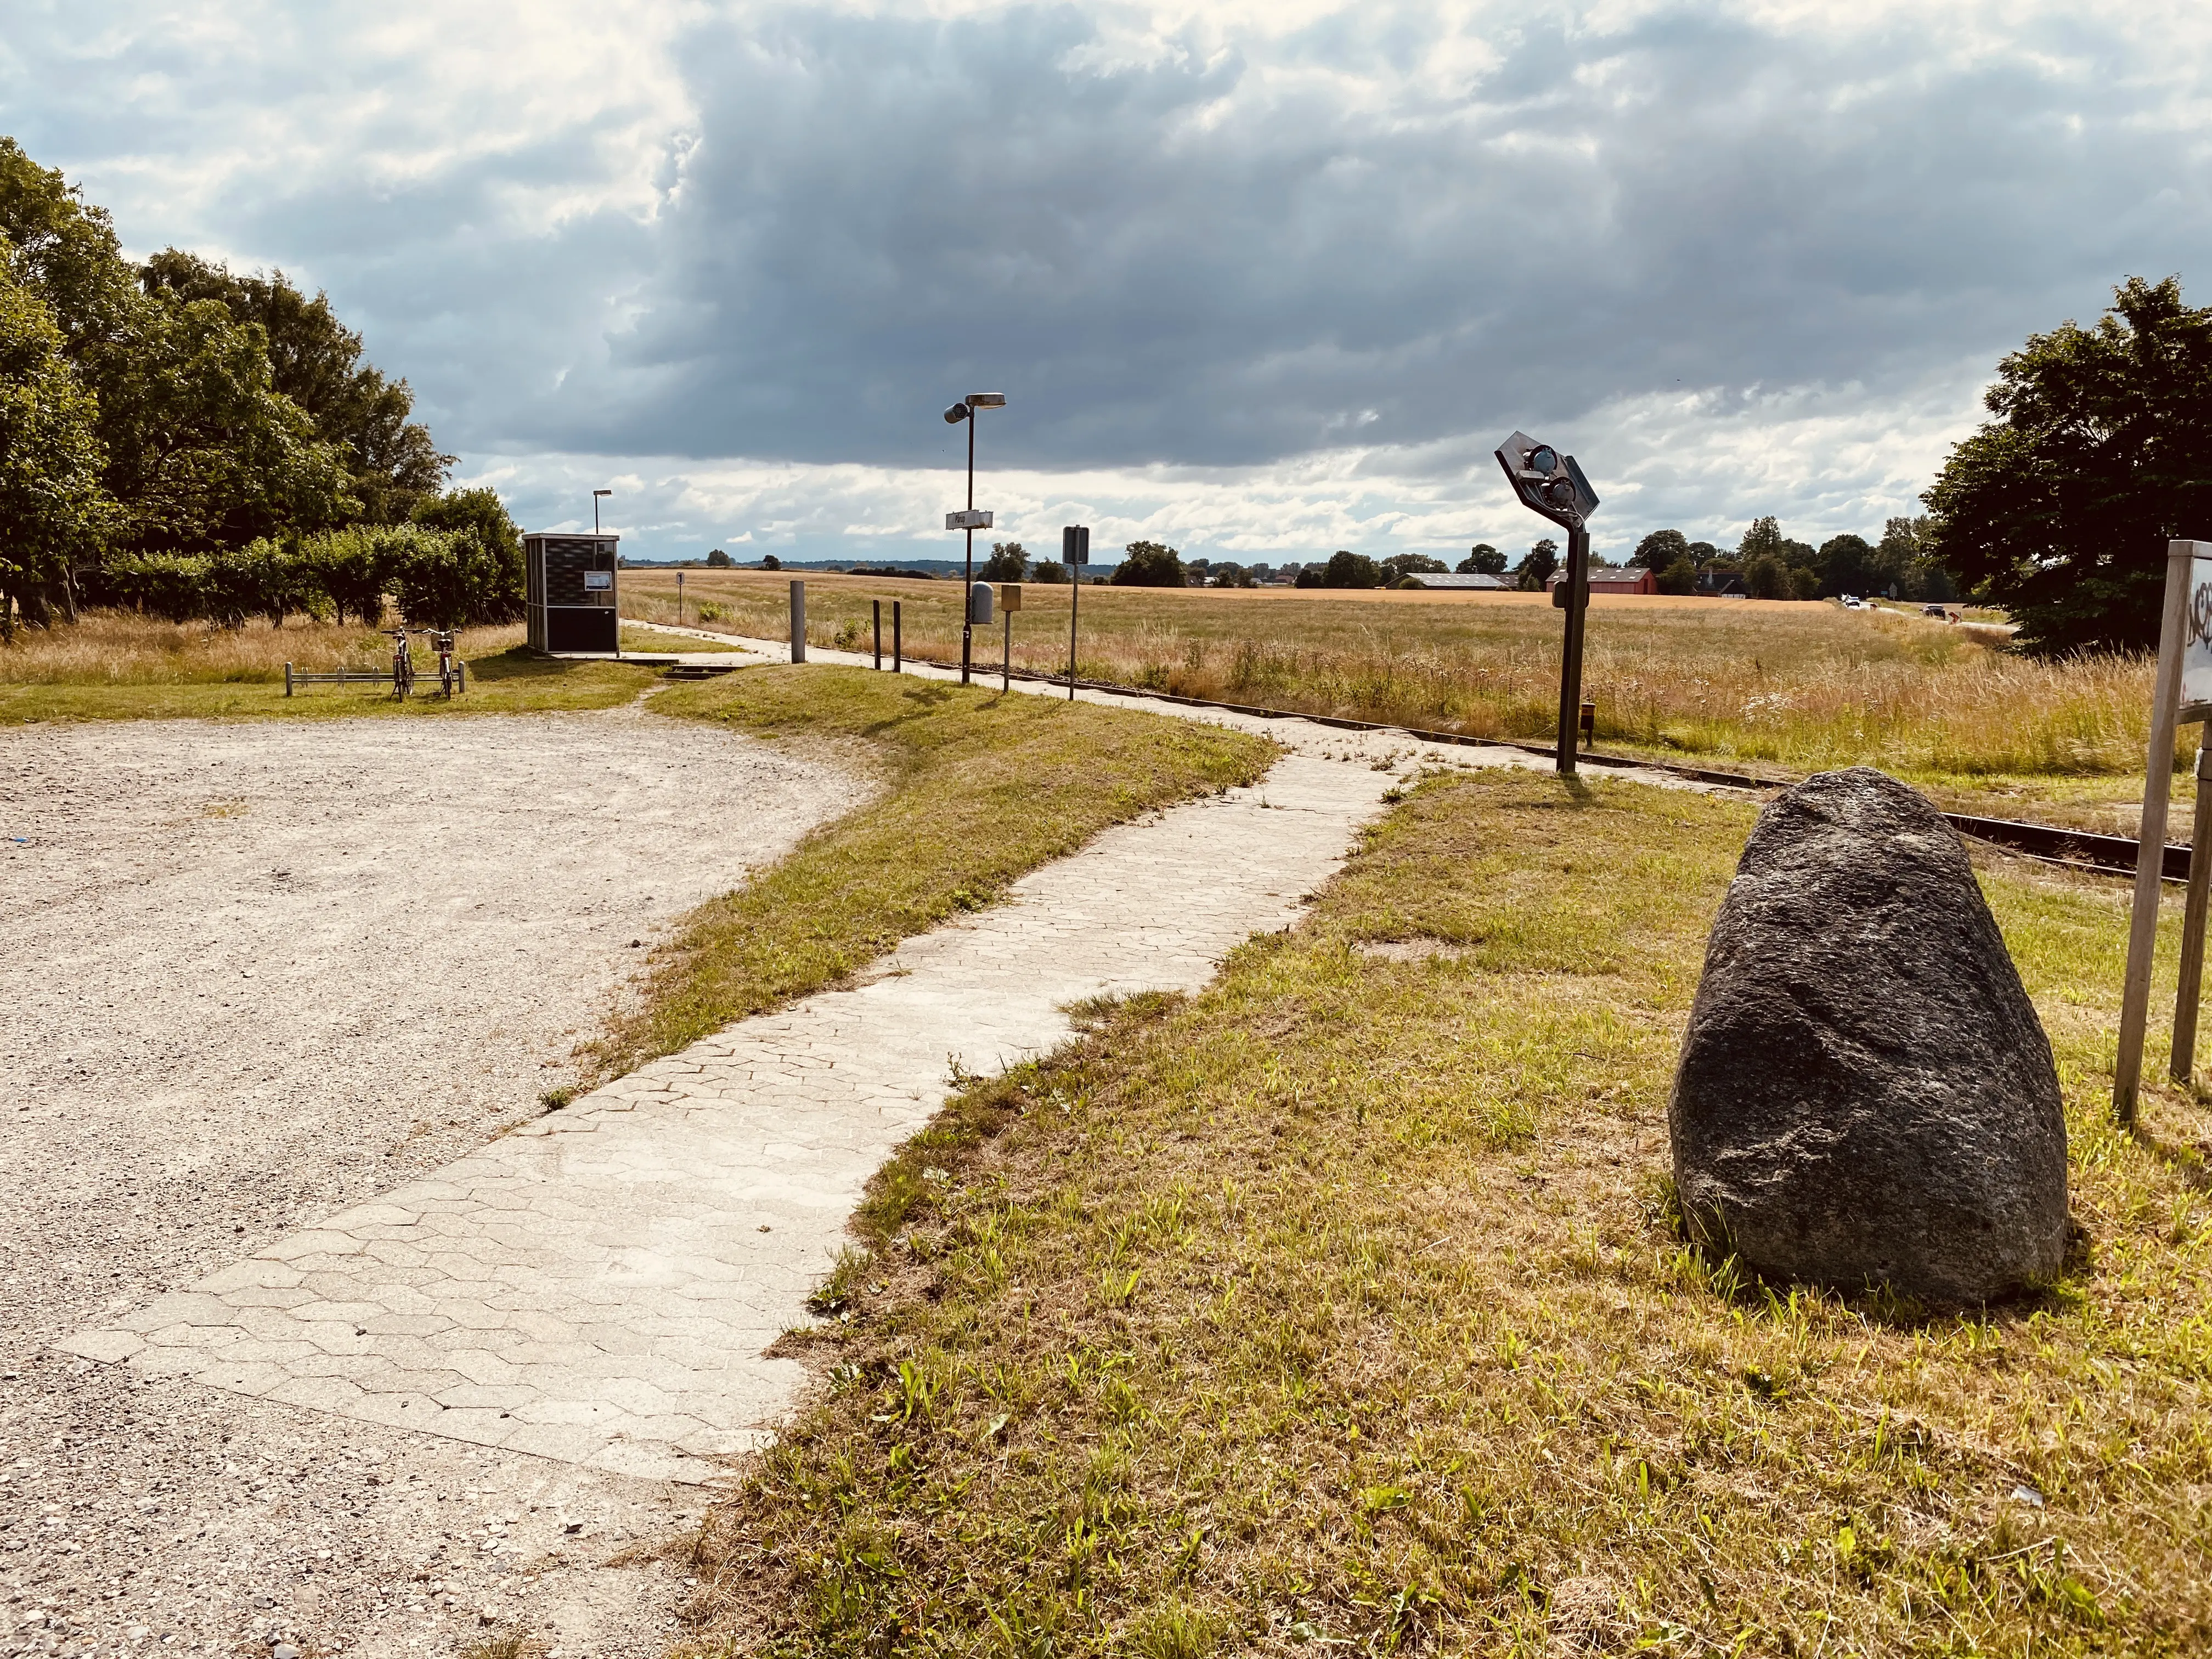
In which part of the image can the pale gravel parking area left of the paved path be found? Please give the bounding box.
[0,710,865,1659]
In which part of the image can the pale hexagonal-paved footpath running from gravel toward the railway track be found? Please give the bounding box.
[64,754,1391,1480]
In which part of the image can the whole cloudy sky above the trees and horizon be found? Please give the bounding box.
[0,0,2212,560]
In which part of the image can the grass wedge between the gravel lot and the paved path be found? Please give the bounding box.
[593,668,1276,1075]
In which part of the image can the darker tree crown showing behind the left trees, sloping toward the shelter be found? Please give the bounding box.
[142,248,454,524]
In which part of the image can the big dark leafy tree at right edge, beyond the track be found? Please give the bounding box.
[1922,276,2212,654]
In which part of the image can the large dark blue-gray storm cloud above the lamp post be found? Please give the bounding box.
[506,7,2205,465]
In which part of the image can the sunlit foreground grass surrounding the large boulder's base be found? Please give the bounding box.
[688,774,2212,1659]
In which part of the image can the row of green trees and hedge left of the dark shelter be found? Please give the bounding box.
[0,137,522,635]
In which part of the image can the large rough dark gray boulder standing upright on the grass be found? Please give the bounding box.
[1668,765,2066,1307]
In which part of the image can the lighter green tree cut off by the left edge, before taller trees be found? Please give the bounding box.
[0,269,115,637]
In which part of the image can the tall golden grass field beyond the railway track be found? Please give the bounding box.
[622,571,2194,832]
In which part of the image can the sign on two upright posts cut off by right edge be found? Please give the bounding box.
[2113,542,2212,1124]
